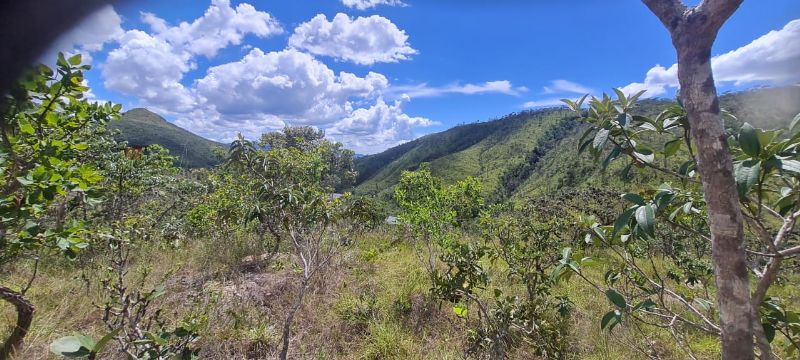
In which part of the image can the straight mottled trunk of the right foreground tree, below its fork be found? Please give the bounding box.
[678,39,753,359]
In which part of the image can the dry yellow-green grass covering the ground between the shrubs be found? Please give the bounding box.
[0,225,798,359]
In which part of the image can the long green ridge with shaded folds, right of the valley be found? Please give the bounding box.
[354,86,800,200]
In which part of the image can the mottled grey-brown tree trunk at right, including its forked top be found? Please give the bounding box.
[642,0,757,359]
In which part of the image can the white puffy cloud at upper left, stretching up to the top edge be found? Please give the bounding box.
[102,0,283,112]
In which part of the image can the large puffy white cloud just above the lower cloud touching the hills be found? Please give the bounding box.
[196,49,388,125]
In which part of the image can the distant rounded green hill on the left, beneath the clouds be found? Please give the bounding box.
[111,108,225,168]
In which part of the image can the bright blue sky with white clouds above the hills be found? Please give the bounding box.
[45,0,800,153]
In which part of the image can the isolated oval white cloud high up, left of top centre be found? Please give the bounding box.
[289,13,417,65]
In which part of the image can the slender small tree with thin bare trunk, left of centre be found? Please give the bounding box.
[230,135,350,359]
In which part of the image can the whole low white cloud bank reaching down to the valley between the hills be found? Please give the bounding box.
[183,48,434,153]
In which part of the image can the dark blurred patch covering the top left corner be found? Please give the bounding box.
[0,0,118,94]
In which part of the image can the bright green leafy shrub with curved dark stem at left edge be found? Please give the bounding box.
[0,54,121,358]
